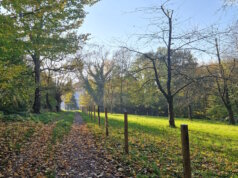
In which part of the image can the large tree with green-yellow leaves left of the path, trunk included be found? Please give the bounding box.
[0,0,96,113]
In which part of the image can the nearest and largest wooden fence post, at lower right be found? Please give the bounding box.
[181,124,192,178]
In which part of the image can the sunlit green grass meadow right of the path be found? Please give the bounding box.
[81,113,238,177]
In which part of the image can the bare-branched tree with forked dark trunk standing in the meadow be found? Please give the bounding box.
[124,1,207,127]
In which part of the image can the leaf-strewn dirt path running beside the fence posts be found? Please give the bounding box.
[55,113,125,177]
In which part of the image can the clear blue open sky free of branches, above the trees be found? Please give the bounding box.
[80,0,238,47]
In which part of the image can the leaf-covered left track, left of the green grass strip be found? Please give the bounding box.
[3,122,54,177]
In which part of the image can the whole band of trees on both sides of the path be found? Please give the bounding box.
[0,0,238,127]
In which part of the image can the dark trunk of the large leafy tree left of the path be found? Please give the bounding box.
[32,55,41,114]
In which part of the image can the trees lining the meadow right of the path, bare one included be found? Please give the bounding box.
[67,1,238,127]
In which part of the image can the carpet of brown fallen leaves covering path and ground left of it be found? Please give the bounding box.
[0,114,124,177]
